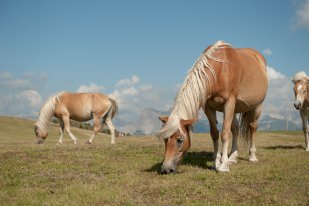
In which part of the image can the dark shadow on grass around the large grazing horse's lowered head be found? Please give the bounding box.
[145,152,213,173]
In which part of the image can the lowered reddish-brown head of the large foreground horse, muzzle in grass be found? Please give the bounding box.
[159,116,196,174]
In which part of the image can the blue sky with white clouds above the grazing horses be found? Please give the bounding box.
[0,0,309,120]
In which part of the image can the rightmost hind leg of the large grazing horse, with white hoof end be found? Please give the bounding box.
[249,105,262,162]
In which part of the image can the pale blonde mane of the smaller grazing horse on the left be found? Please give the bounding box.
[35,91,65,131]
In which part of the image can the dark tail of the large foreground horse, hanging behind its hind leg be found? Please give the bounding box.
[239,110,255,145]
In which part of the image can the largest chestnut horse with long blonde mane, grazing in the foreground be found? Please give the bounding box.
[157,41,268,174]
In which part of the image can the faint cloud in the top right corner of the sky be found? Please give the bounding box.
[295,0,309,29]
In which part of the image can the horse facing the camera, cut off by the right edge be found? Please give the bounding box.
[292,72,309,151]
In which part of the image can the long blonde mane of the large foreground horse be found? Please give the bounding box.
[157,41,231,139]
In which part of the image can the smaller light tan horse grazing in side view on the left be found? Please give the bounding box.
[34,92,118,144]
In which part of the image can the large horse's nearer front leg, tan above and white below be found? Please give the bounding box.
[218,96,235,172]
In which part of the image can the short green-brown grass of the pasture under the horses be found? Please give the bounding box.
[0,117,309,206]
